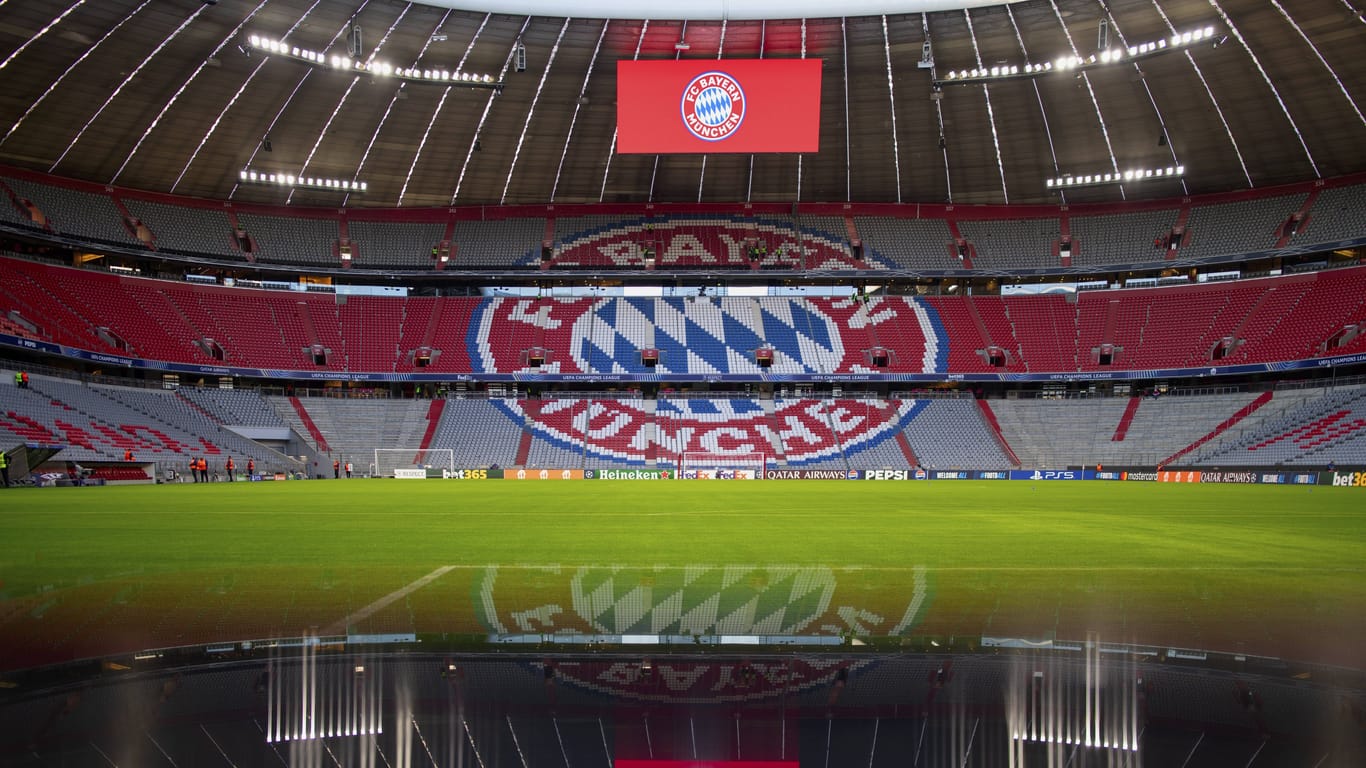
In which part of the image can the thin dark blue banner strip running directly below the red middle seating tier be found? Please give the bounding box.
[0,333,1366,382]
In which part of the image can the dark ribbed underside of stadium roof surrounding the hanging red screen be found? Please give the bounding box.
[0,0,1366,206]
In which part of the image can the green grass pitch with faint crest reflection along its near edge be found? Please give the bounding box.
[0,480,1366,668]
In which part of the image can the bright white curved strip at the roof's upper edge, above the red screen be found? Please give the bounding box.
[410,0,1020,20]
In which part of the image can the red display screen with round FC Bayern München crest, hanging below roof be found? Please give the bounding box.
[616,59,821,154]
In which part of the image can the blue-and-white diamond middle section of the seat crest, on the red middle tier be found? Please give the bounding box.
[467,297,948,379]
